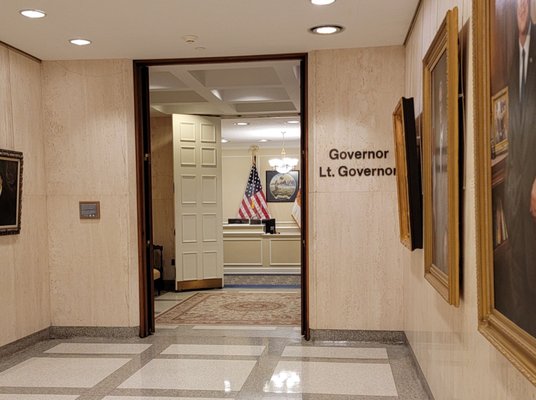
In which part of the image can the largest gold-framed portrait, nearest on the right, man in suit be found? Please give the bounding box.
[473,0,536,385]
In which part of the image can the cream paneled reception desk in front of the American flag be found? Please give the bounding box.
[223,223,301,274]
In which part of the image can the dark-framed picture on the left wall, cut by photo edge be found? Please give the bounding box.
[0,149,22,235]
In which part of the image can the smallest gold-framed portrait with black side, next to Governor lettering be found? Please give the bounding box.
[393,97,422,250]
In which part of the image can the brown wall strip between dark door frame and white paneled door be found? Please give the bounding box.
[151,116,175,280]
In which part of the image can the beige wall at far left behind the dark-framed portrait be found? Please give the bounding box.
[0,45,51,346]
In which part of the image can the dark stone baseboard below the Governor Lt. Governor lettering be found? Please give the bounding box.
[311,329,408,344]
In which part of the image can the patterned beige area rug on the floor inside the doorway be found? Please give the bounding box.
[156,292,301,325]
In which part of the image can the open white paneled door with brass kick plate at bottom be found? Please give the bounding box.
[173,114,223,291]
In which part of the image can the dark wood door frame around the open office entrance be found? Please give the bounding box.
[133,53,310,340]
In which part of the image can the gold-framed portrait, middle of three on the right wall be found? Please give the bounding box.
[422,8,460,306]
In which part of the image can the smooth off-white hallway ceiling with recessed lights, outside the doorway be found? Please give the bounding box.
[0,0,419,60]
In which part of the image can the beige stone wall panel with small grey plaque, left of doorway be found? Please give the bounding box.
[42,60,139,327]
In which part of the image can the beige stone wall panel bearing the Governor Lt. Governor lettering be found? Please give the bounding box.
[308,46,404,330]
